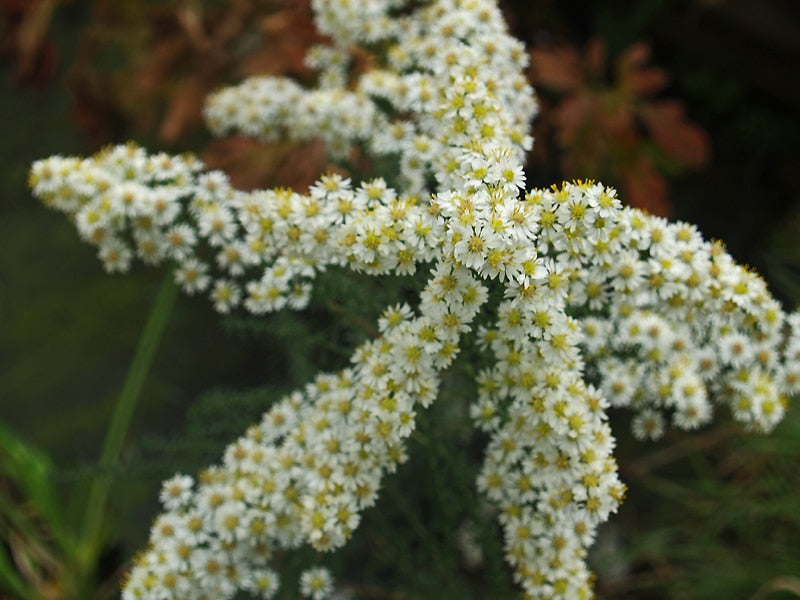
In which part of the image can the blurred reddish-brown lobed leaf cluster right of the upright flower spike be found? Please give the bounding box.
[531,38,710,216]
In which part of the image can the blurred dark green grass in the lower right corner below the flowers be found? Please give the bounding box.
[594,406,800,600]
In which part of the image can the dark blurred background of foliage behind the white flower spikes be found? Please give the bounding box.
[0,0,800,599]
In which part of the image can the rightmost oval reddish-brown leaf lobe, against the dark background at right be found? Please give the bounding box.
[640,100,711,169]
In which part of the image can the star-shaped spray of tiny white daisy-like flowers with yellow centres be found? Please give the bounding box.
[31,0,800,599]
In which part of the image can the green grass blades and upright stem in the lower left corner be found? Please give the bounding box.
[0,279,176,600]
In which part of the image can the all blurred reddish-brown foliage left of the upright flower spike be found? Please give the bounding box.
[0,0,326,189]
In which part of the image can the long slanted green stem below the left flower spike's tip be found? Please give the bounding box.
[76,274,177,597]
